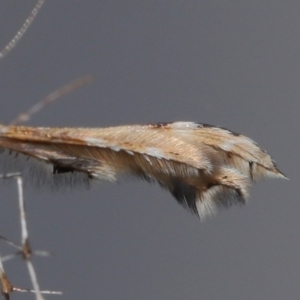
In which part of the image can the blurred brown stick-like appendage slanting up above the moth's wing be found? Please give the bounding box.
[9,75,93,125]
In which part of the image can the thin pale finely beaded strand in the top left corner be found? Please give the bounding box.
[0,0,45,59]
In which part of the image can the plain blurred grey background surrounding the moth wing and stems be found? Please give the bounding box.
[0,0,300,300]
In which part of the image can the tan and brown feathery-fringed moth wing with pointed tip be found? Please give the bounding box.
[0,122,286,219]
